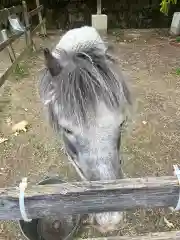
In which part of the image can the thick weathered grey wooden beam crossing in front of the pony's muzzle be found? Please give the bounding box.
[0,176,179,220]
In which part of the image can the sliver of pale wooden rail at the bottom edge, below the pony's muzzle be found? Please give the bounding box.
[76,231,180,240]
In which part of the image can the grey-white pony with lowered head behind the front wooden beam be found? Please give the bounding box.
[39,26,131,232]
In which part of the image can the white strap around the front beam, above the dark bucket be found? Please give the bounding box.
[19,178,32,222]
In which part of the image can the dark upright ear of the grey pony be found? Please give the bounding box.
[44,48,61,76]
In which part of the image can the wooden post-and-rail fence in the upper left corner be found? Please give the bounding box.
[0,0,46,87]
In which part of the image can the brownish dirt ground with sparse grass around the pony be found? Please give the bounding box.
[0,31,180,240]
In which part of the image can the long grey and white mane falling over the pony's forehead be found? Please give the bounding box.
[39,30,131,129]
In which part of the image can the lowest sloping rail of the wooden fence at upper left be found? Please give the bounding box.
[0,45,32,87]
